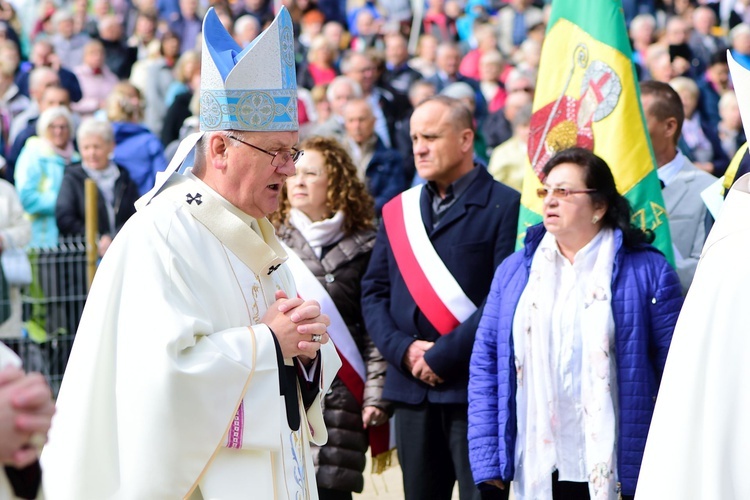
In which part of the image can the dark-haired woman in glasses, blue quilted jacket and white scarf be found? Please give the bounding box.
[468,148,682,500]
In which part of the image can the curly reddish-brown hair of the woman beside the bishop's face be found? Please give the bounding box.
[269,136,375,235]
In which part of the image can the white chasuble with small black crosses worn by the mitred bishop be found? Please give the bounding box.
[42,174,340,500]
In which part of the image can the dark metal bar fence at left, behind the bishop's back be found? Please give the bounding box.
[0,237,87,395]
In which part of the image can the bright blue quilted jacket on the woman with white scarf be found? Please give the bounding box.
[469,224,682,495]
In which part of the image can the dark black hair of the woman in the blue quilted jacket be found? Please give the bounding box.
[542,148,654,248]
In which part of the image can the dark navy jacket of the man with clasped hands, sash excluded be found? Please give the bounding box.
[362,167,520,405]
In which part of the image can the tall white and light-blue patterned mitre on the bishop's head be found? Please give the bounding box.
[200,7,299,132]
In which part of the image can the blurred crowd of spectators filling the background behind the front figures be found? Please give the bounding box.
[0,0,750,249]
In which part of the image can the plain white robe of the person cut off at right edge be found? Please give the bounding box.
[635,174,750,500]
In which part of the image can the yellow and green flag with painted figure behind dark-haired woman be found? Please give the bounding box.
[517,0,674,262]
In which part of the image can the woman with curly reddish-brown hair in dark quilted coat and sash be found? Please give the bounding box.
[270,137,390,500]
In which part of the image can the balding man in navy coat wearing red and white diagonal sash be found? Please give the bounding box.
[362,96,520,500]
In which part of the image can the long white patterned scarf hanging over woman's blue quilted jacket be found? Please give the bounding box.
[513,229,619,500]
